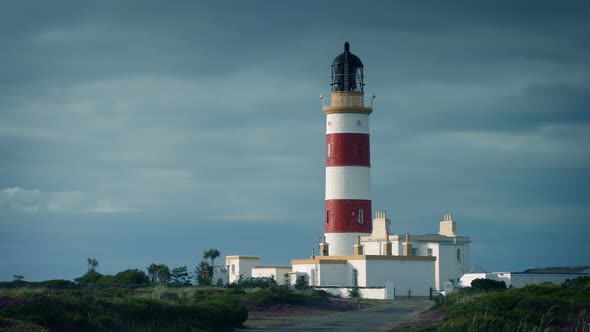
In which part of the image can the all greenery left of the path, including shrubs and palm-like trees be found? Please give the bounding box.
[0,249,336,331]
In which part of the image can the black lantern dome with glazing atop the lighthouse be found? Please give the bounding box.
[331,42,365,92]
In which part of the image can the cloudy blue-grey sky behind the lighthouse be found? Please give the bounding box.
[0,0,590,281]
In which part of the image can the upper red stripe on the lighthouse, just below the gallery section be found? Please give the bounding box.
[326,134,371,167]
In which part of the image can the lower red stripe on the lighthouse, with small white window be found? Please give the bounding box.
[325,199,373,233]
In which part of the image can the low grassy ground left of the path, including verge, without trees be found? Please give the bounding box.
[0,284,368,331]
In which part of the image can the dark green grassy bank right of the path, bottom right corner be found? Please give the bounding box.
[434,277,590,331]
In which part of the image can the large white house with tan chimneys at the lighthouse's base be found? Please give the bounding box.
[292,211,471,297]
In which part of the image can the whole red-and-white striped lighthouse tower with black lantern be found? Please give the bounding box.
[320,42,373,256]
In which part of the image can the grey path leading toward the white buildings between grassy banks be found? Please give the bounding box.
[240,300,433,332]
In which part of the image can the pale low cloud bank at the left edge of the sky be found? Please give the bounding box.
[0,187,139,214]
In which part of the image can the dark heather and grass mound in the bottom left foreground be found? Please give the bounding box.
[0,286,248,331]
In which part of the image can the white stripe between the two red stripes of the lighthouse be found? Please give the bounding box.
[326,166,371,199]
